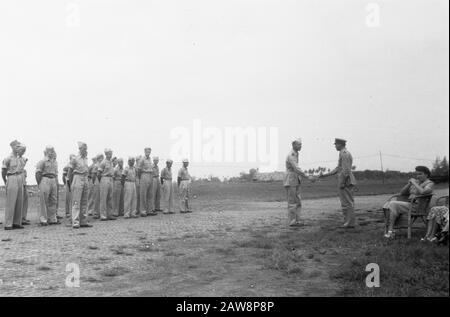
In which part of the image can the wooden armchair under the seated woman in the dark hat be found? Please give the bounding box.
[383,195,433,239]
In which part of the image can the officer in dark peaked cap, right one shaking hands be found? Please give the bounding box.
[320,139,356,228]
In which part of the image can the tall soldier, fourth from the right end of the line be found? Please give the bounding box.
[138,148,156,217]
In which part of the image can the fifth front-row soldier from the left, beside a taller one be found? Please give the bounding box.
[122,157,138,219]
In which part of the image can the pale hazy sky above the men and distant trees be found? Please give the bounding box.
[0,0,449,180]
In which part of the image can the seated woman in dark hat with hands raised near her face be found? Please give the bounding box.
[383,166,434,239]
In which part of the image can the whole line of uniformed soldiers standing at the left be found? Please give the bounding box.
[2,141,192,230]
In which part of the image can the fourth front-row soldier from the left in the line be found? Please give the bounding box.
[97,149,116,221]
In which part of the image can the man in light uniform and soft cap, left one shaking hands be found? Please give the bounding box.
[284,139,315,227]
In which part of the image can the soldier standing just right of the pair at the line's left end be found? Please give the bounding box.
[36,146,59,226]
